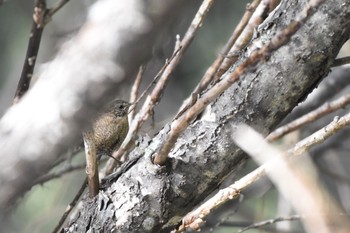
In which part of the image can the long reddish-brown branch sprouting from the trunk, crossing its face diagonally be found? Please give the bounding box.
[153,0,324,165]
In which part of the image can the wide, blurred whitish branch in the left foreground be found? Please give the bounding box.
[0,0,184,211]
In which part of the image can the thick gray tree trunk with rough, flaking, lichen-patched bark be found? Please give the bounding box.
[66,0,350,233]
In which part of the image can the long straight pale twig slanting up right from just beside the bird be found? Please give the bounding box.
[106,0,214,174]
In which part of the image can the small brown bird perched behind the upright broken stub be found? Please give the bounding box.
[92,100,130,157]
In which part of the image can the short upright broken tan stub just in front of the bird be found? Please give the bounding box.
[83,130,99,198]
